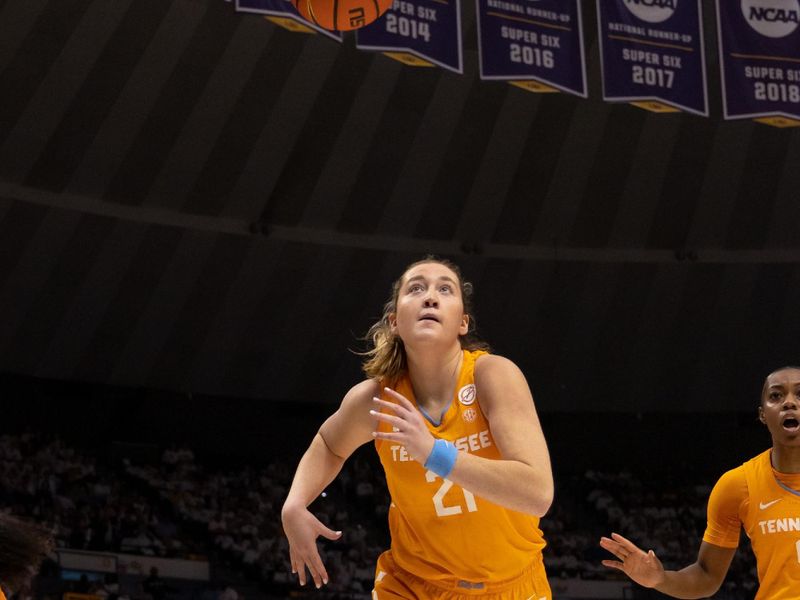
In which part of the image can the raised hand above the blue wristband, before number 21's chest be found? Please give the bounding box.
[370,388,434,464]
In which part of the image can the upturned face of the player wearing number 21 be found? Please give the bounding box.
[390,262,469,344]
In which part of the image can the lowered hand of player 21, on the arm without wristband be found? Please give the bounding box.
[281,506,342,588]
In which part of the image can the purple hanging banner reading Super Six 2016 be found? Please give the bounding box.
[476,0,588,98]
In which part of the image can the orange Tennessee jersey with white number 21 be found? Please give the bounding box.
[375,350,545,586]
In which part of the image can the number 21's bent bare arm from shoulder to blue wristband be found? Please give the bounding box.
[447,354,553,516]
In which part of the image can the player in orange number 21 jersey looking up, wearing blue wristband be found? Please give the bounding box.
[282,258,553,600]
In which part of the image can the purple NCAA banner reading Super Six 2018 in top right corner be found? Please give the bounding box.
[717,0,800,127]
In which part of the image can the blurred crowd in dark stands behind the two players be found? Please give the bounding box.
[0,433,757,600]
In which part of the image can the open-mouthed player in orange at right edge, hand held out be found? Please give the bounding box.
[600,367,800,600]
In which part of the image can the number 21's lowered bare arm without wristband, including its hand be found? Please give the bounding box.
[281,380,380,587]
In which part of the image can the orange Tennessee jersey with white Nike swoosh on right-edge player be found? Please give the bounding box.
[703,450,800,600]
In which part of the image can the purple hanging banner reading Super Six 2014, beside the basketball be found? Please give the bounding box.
[356,0,463,73]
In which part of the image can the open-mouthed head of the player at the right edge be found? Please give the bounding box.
[759,369,800,446]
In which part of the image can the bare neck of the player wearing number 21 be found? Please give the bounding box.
[407,345,464,409]
